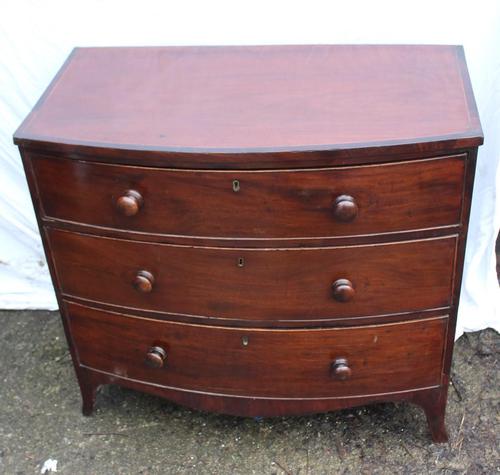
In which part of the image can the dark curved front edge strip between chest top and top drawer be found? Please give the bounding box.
[14,142,482,171]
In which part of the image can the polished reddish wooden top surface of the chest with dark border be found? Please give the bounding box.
[15,45,482,158]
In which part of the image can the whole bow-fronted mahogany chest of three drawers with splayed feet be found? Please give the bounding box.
[15,46,483,441]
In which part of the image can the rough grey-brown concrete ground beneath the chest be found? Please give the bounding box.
[0,311,500,475]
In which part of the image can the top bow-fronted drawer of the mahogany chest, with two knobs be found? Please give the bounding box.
[31,155,465,239]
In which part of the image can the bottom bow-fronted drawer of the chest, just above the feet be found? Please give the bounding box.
[66,302,447,399]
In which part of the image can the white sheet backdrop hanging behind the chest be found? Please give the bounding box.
[0,0,500,336]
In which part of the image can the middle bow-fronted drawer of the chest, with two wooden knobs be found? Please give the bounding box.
[47,229,456,320]
